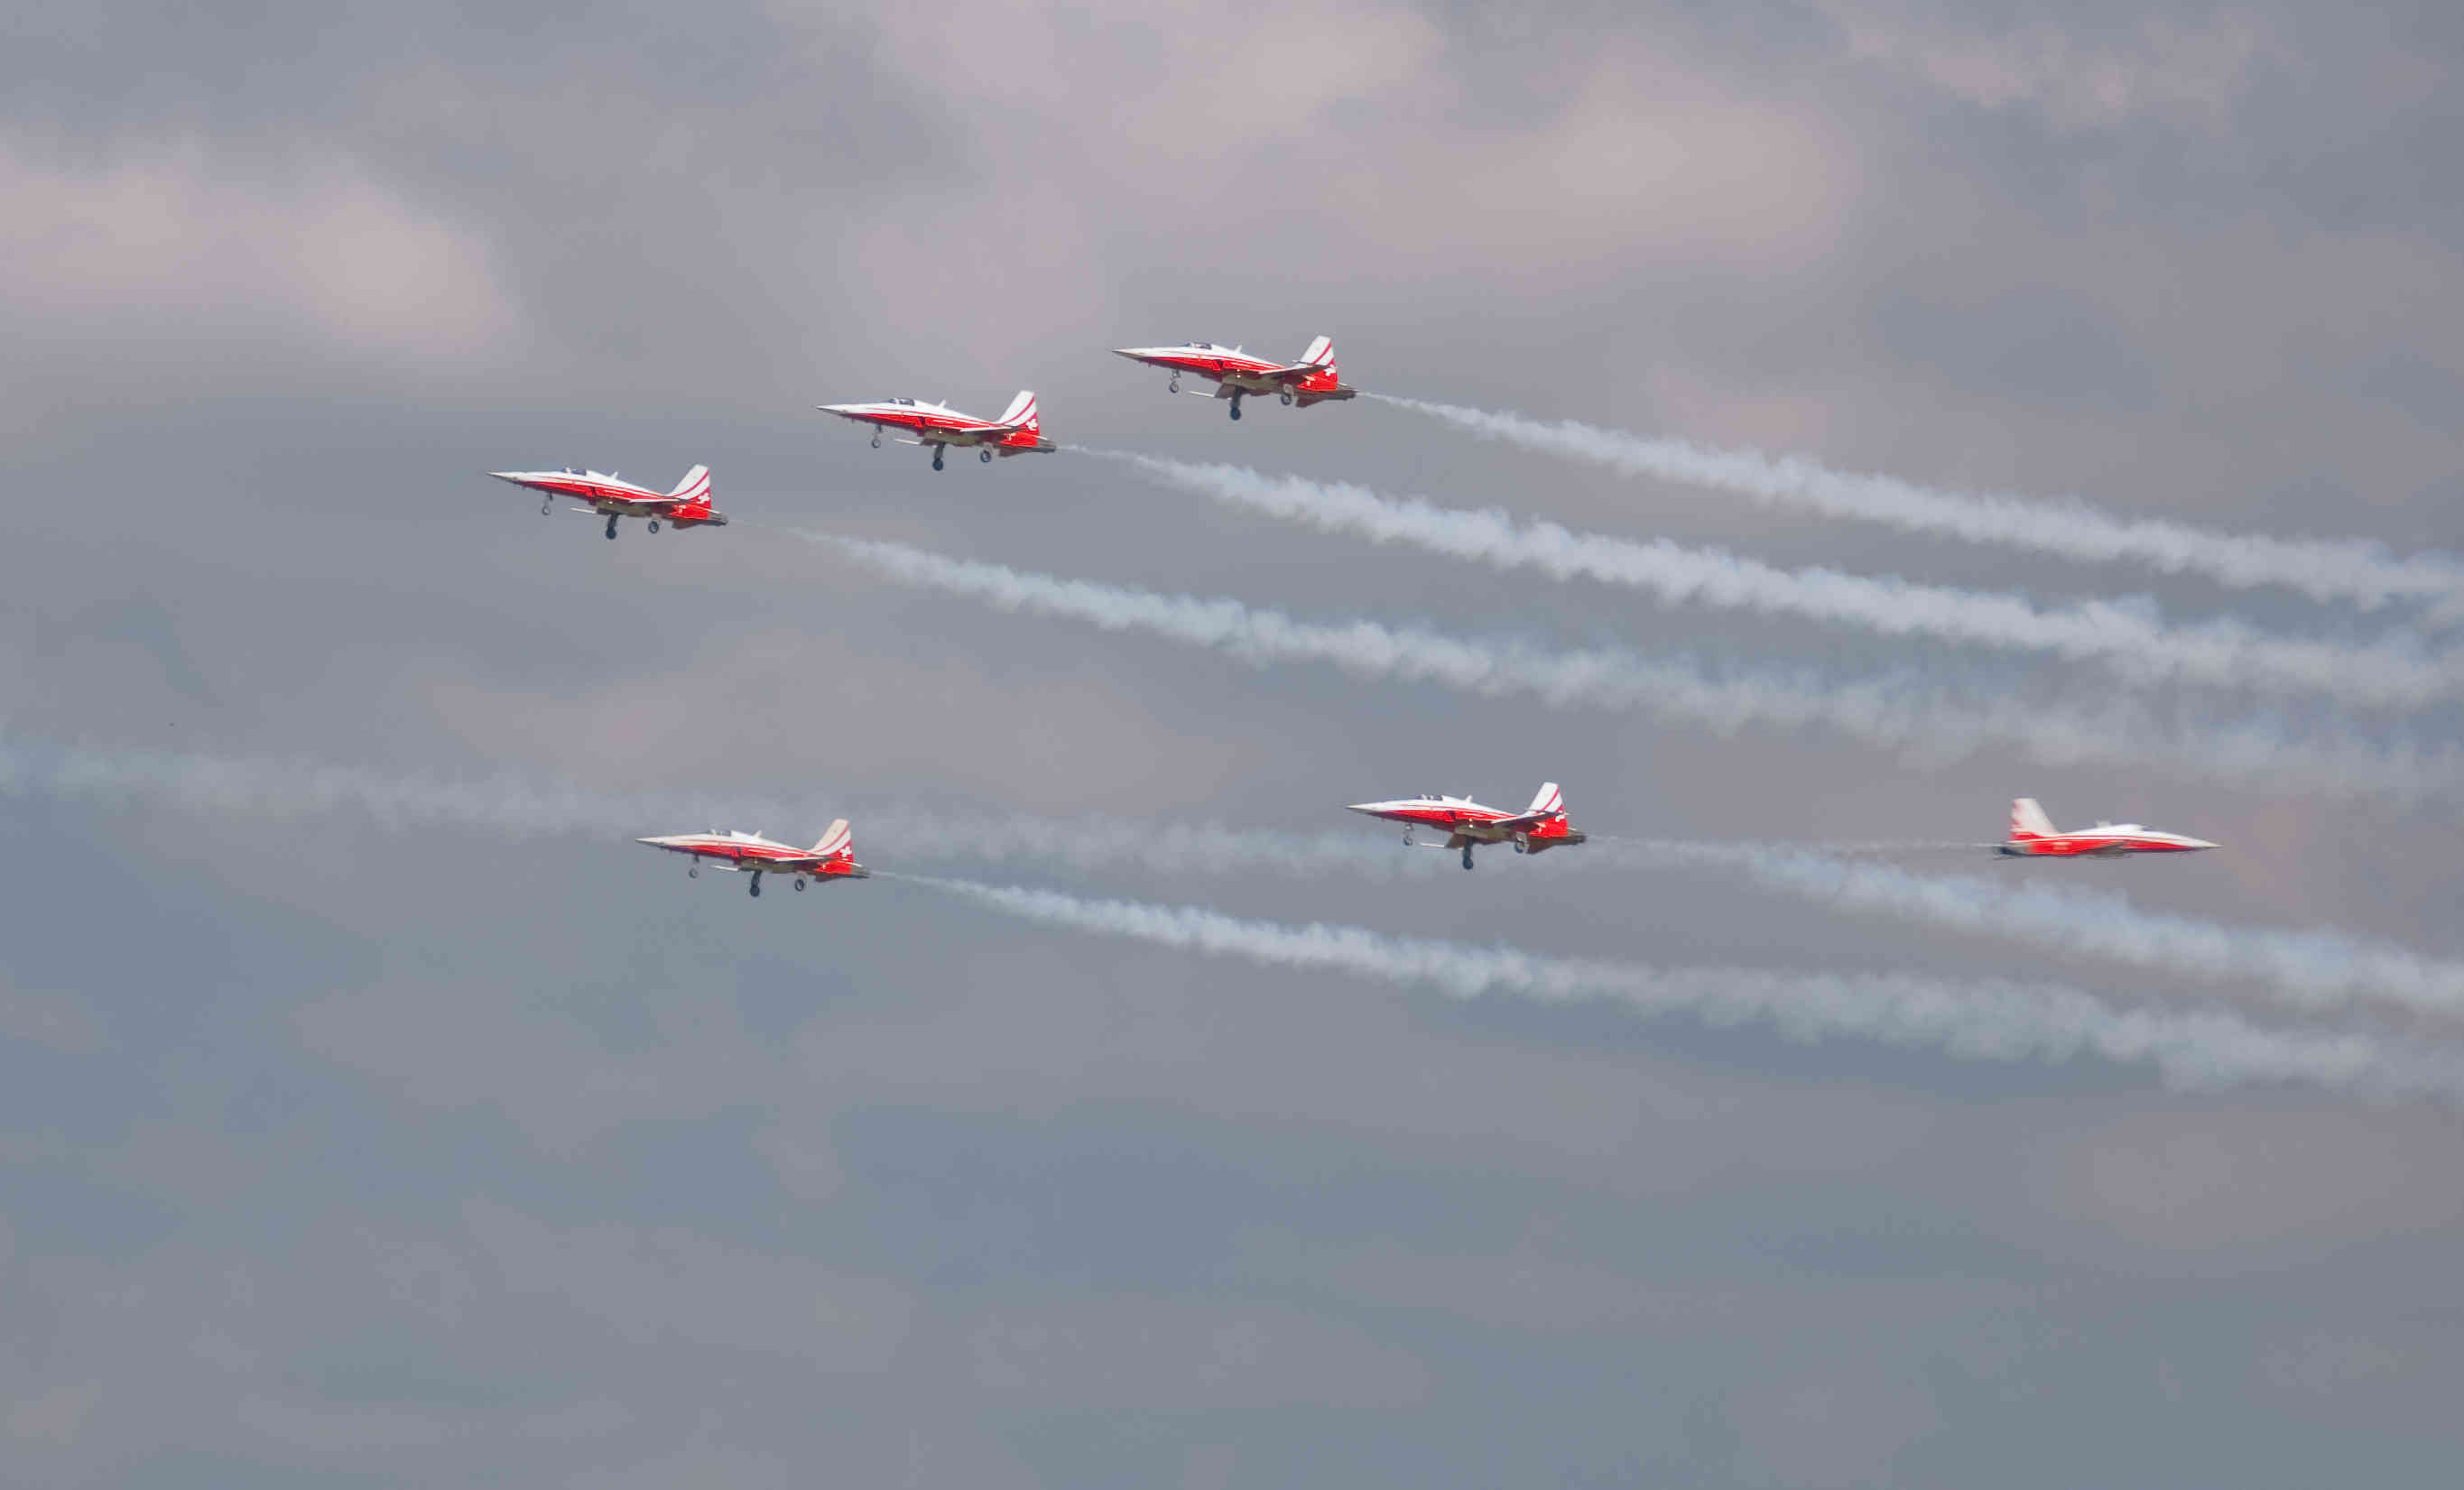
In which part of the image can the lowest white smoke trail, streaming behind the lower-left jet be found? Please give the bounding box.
[890,875,2464,1104]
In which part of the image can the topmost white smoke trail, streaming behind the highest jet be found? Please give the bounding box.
[1367,394,2464,611]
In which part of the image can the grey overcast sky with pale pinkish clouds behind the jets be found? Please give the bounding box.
[0,0,2464,1490]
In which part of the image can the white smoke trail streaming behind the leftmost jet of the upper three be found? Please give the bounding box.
[803,534,2464,803]
